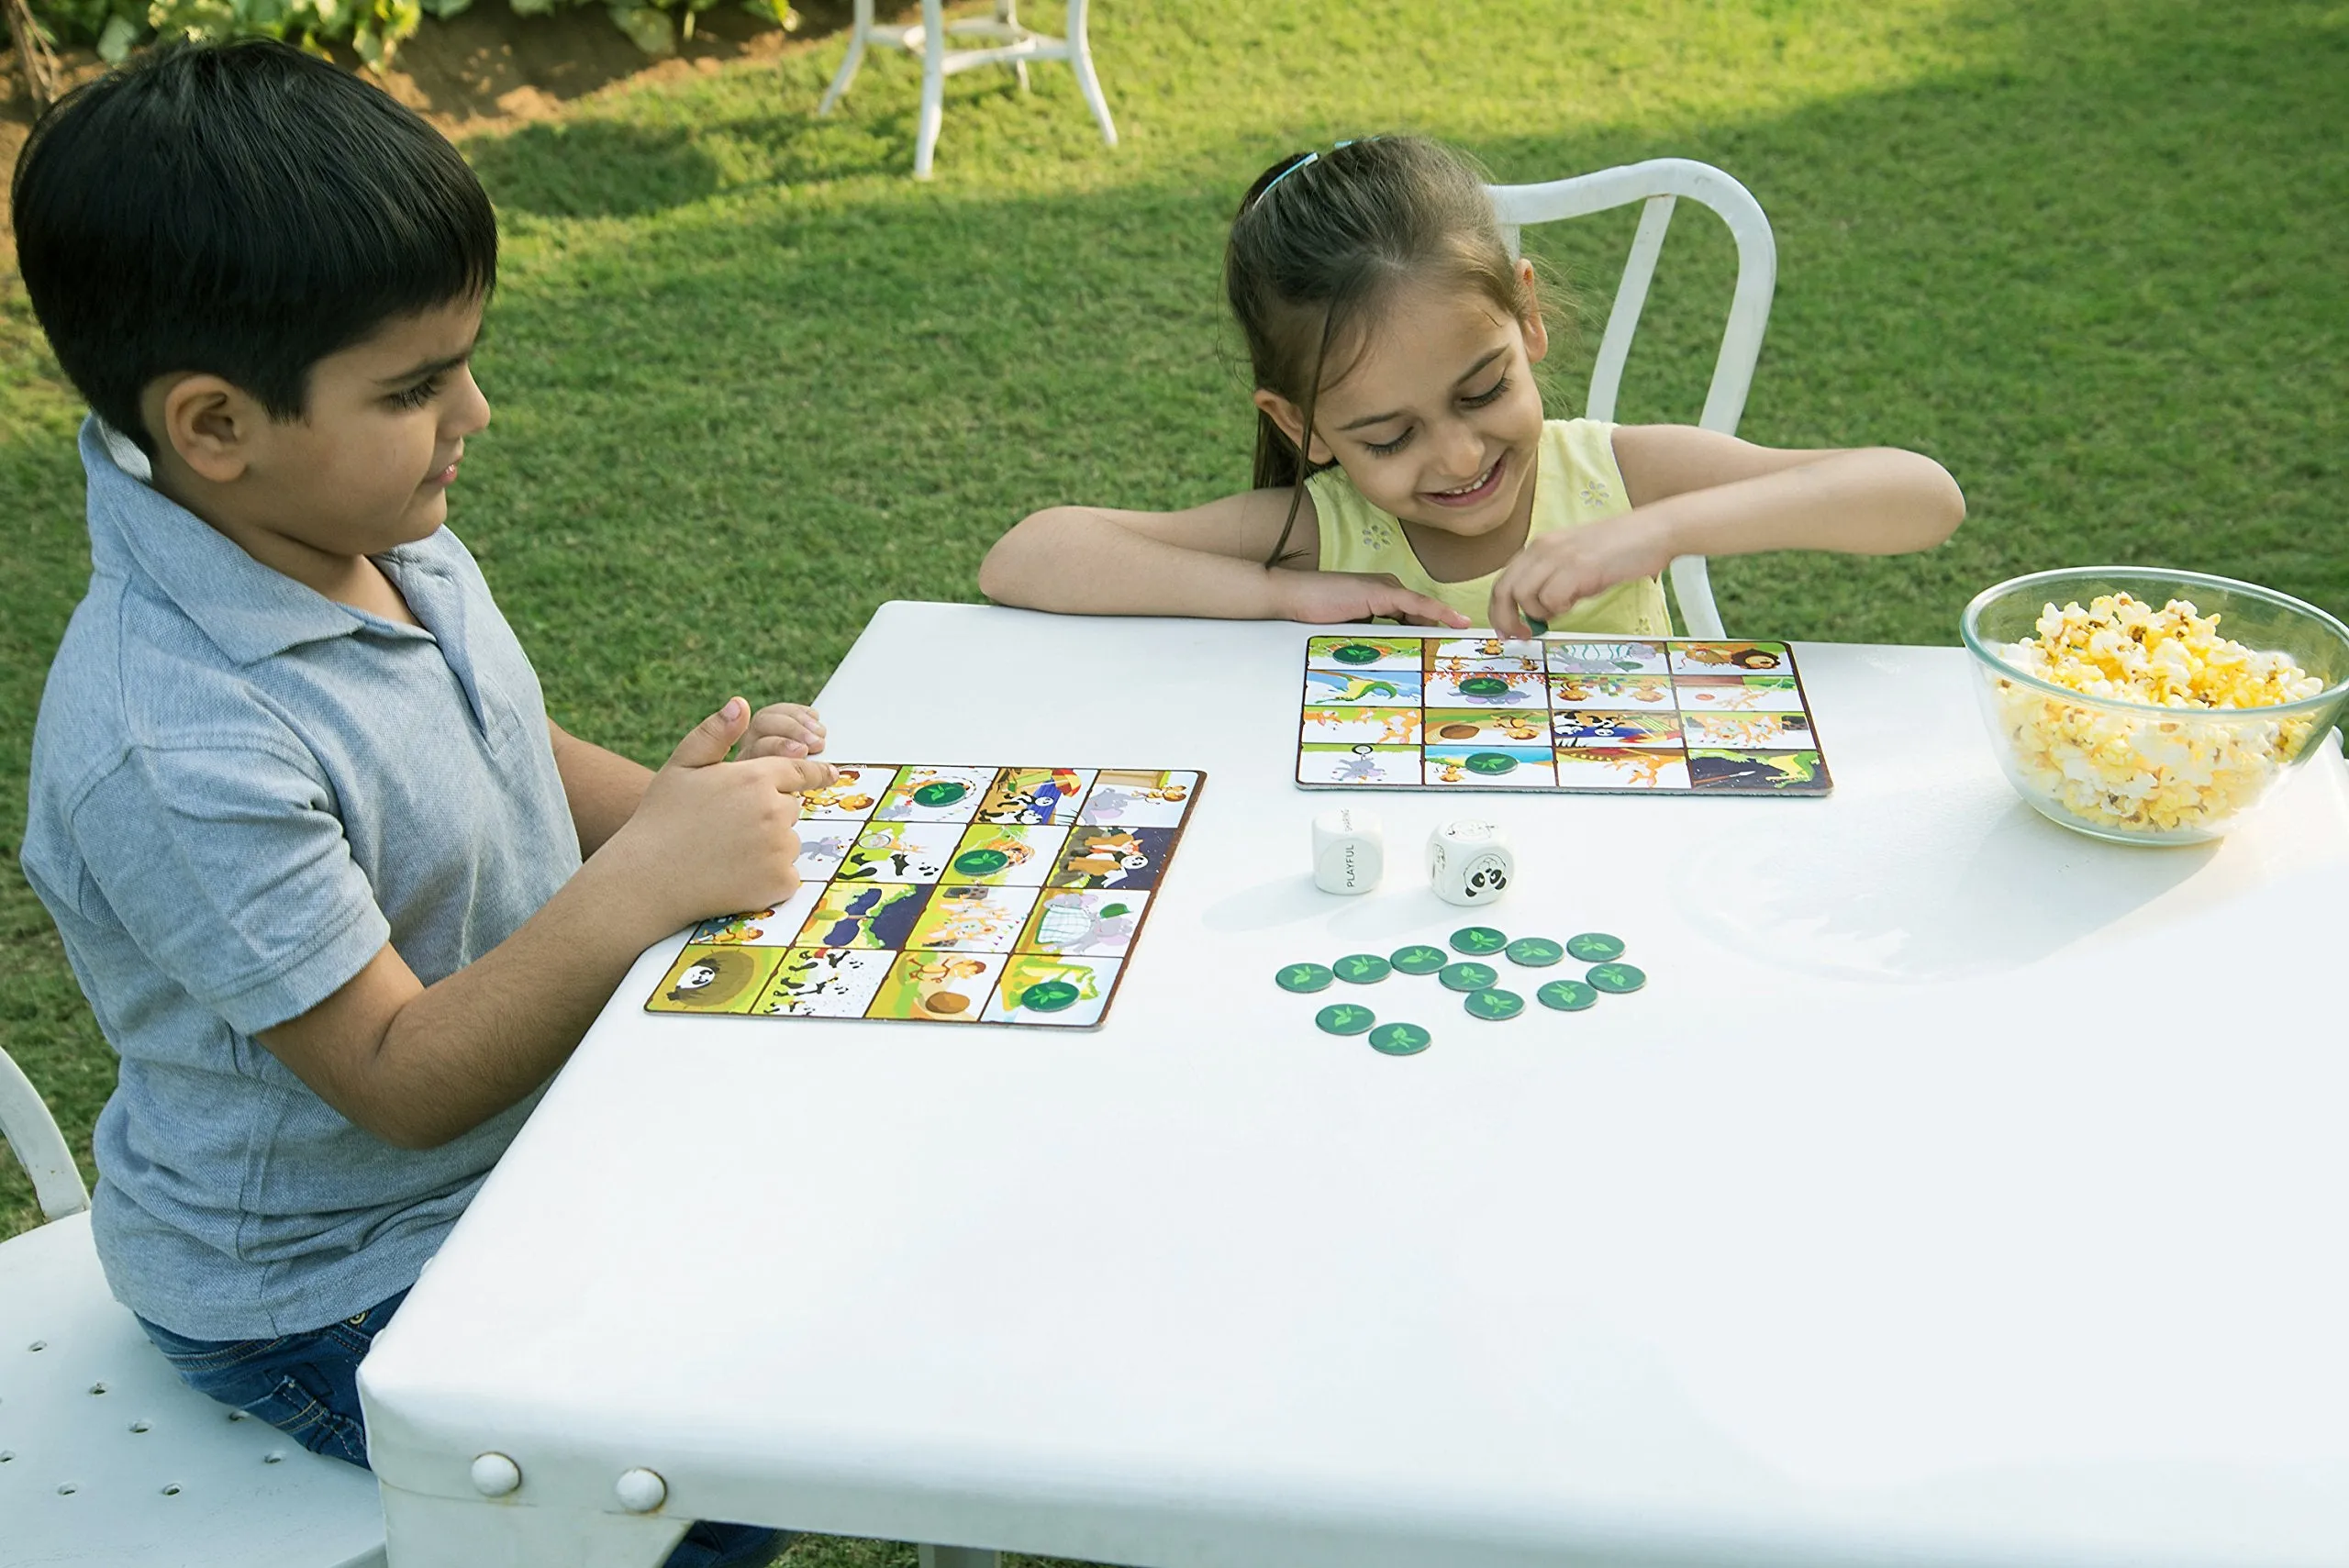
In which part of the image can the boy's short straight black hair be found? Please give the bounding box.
[9,39,498,455]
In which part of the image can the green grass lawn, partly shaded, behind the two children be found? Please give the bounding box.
[0,0,2349,1563]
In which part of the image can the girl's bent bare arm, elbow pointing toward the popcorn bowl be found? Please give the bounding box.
[1644,446,1966,556]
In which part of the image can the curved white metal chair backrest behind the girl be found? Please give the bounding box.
[1486,157,1778,636]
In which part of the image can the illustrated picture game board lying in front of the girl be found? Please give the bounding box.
[1297,634,1830,795]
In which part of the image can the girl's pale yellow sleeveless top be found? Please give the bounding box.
[1306,420,1673,636]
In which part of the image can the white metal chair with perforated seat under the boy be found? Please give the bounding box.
[0,1051,383,1568]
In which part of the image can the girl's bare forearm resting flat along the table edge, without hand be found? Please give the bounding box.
[980,507,1280,619]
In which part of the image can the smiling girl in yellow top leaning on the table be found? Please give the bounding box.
[980,136,1966,636]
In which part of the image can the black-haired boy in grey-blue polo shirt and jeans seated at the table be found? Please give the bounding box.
[12,42,812,1568]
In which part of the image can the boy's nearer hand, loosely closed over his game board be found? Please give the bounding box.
[606,697,834,932]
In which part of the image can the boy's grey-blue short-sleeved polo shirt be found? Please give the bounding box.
[24,420,578,1340]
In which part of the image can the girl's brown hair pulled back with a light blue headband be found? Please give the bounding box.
[1224,136,1536,566]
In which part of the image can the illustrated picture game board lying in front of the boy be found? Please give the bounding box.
[643,762,1205,1029]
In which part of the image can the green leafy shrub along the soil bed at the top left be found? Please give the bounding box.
[6,0,798,66]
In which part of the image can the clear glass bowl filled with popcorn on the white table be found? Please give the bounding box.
[1959,566,2349,845]
